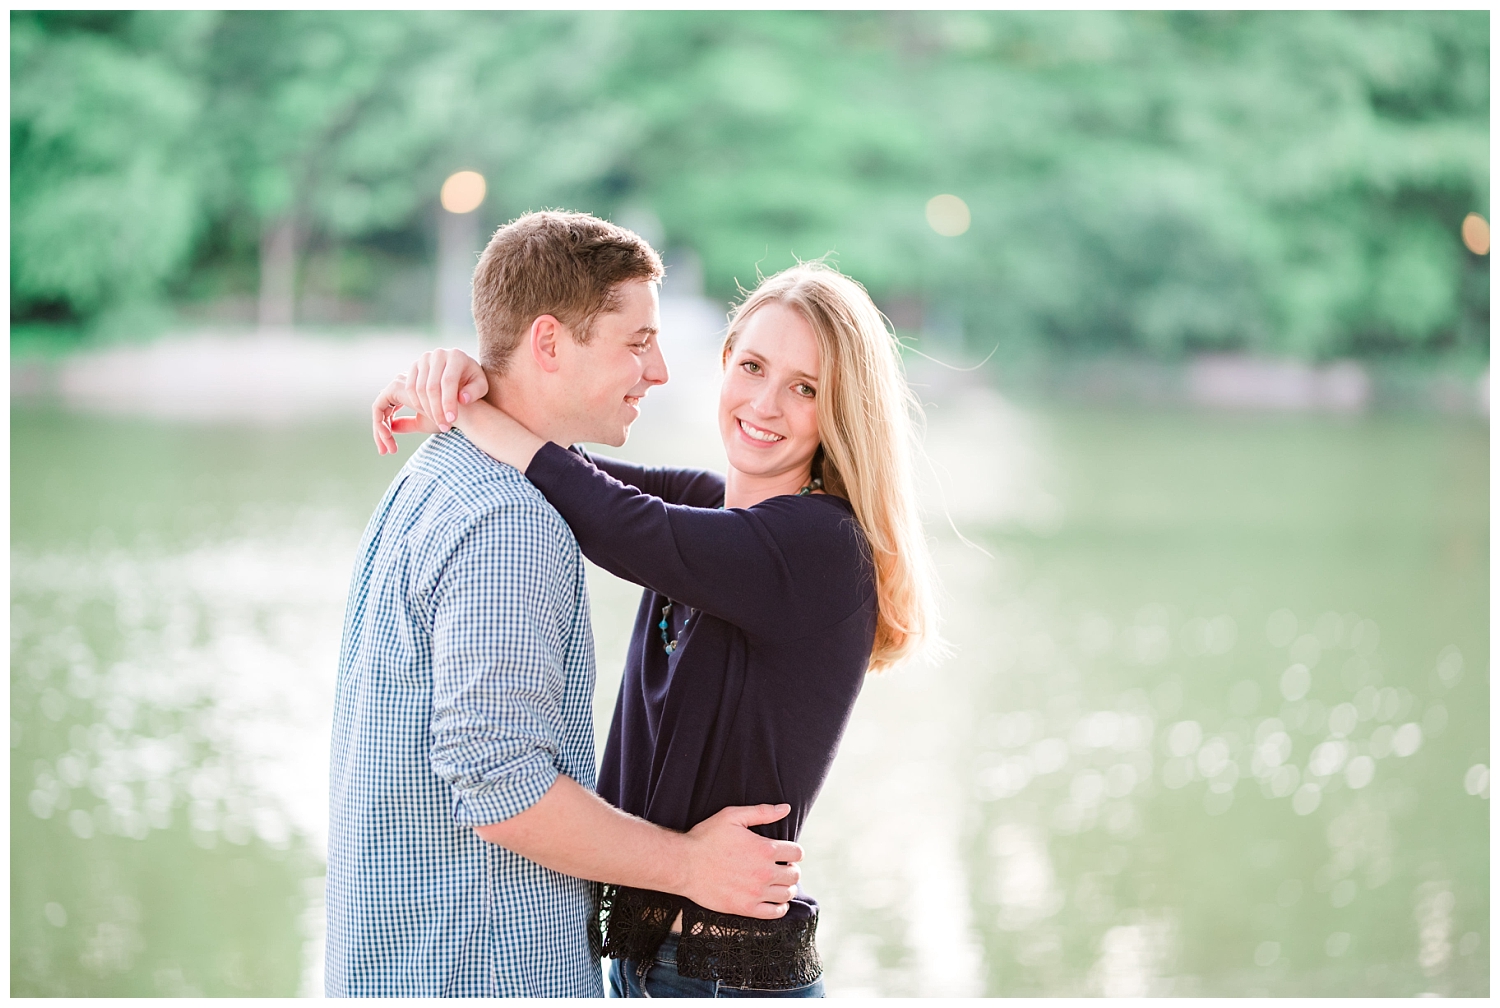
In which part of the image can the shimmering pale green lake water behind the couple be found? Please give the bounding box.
[11,389,1490,996]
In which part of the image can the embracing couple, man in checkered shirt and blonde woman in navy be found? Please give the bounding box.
[327,212,936,998]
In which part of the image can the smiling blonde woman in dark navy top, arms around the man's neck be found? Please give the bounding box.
[377,263,936,998]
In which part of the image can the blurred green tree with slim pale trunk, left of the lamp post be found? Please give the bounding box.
[204,11,486,327]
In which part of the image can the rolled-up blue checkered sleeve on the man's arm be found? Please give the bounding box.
[431,509,575,827]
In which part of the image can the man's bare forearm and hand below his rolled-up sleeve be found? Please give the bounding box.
[474,776,803,918]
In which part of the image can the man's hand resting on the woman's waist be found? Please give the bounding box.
[677,806,803,920]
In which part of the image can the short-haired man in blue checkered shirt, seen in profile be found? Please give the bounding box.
[326,213,801,998]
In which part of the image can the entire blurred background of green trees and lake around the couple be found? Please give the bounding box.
[11,11,1491,998]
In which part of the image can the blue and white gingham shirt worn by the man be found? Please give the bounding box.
[326,431,603,998]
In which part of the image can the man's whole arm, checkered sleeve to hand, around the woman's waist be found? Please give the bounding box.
[429,503,803,918]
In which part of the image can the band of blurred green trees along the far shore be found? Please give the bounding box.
[11,11,1490,360]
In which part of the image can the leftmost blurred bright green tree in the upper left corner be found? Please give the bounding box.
[11,11,212,336]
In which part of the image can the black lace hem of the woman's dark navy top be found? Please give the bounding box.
[590,884,824,990]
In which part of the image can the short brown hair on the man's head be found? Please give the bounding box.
[474,210,662,375]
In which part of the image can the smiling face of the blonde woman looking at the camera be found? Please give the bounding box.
[719,302,819,477]
